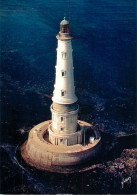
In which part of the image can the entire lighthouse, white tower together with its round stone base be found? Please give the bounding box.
[21,18,101,172]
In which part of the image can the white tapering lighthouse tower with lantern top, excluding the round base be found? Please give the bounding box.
[49,17,82,146]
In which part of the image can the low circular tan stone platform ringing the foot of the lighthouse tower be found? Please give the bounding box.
[21,121,101,172]
